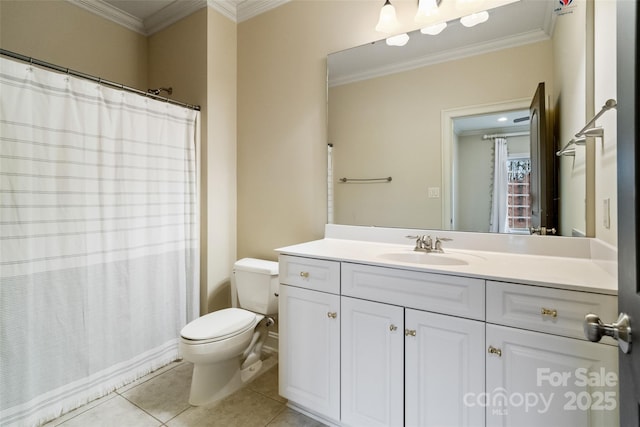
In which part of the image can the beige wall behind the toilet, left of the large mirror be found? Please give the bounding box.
[238,0,390,259]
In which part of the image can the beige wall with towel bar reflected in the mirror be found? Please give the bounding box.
[329,41,553,229]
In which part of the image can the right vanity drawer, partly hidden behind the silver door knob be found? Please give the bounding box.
[487,281,618,345]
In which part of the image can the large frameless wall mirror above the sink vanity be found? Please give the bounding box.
[327,0,600,235]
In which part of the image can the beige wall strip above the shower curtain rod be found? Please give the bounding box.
[0,0,147,90]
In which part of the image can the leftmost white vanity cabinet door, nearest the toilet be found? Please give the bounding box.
[279,285,340,420]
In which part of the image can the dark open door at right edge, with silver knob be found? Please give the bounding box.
[616,1,640,426]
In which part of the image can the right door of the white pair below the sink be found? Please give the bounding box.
[405,309,485,427]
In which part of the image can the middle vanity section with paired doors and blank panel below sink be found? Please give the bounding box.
[341,263,485,427]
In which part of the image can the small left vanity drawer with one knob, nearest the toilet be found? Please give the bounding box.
[279,255,340,294]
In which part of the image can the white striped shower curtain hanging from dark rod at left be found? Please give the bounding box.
[0,58,199,426]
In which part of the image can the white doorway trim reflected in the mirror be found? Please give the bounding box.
[440,98,531,230]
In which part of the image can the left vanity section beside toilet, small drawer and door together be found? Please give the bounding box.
[278,256,340,421]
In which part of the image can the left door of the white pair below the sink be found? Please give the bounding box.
[341,297,404,427]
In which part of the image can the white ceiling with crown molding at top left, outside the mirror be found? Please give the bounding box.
[72,0,289,35]
